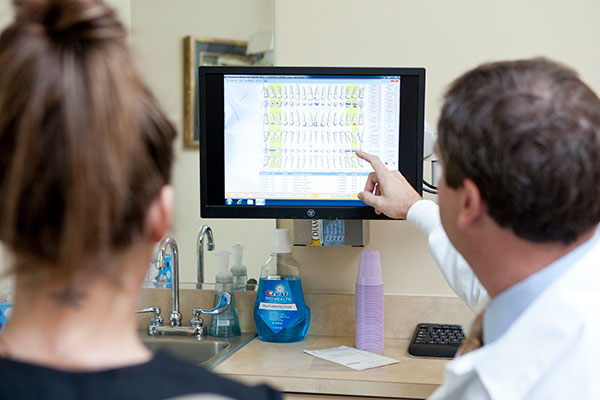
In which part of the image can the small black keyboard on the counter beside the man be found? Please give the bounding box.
[408,324,464,358]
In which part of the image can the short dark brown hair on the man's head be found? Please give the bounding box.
[438,58,600,243]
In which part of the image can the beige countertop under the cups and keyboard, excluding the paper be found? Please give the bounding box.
[214,335,448,398]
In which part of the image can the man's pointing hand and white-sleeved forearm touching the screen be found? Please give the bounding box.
[356,151,489,312]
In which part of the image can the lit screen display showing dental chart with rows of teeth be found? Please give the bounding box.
[223,74,402,206]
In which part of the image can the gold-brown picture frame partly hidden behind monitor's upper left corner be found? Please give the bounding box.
[183,36,255,149]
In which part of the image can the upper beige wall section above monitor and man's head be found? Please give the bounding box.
[274,0,600,126]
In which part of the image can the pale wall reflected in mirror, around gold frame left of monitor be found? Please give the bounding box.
[131,0,275,282]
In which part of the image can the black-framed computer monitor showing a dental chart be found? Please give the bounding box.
[198,67,425,219]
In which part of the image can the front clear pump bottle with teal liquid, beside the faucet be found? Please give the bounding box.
[208,251,241,337]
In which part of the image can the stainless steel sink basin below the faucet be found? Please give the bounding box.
[140,332,256,369]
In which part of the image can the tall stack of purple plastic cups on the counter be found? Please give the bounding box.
[355,250,383,352]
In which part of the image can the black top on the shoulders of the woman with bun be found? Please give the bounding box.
[0,352,282,400]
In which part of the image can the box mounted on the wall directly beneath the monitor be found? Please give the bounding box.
[294,219,369,247]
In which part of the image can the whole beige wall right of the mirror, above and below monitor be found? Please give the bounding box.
[274,0,600,294]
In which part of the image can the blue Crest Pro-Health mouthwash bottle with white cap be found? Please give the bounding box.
[254,229,310,343]
